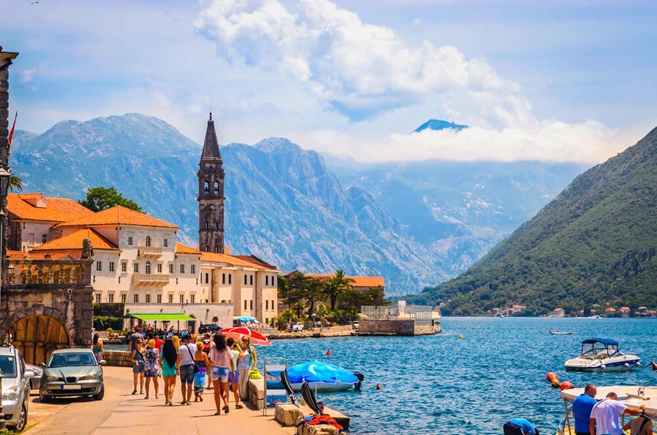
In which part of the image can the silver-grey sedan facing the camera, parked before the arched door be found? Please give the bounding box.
[39,348,106,402]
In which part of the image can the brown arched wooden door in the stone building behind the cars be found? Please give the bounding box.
[11,315,71,365]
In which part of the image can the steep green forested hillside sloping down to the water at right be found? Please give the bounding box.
[407,129,657,315]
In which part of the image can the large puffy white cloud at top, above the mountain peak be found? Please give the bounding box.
[195,0,528,125]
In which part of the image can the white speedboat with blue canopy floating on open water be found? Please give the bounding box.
[564,338,640,372]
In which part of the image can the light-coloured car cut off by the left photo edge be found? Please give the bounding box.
[0,346,34,432]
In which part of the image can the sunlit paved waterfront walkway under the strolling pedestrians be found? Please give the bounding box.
[25,367,295,435]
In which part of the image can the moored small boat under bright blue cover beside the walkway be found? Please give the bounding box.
[287,361,363,391]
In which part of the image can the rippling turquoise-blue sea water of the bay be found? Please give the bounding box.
[258,318,657,434]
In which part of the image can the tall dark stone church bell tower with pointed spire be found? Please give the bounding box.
[197,112,225,254]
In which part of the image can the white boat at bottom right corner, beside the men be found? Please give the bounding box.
[556,385,657,435]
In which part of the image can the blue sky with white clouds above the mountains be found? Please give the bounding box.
[0,0,657,163]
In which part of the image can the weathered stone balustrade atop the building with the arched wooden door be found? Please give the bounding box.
[2,255,93,289]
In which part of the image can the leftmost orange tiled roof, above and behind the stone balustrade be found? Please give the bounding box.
[7,193,94,222]
